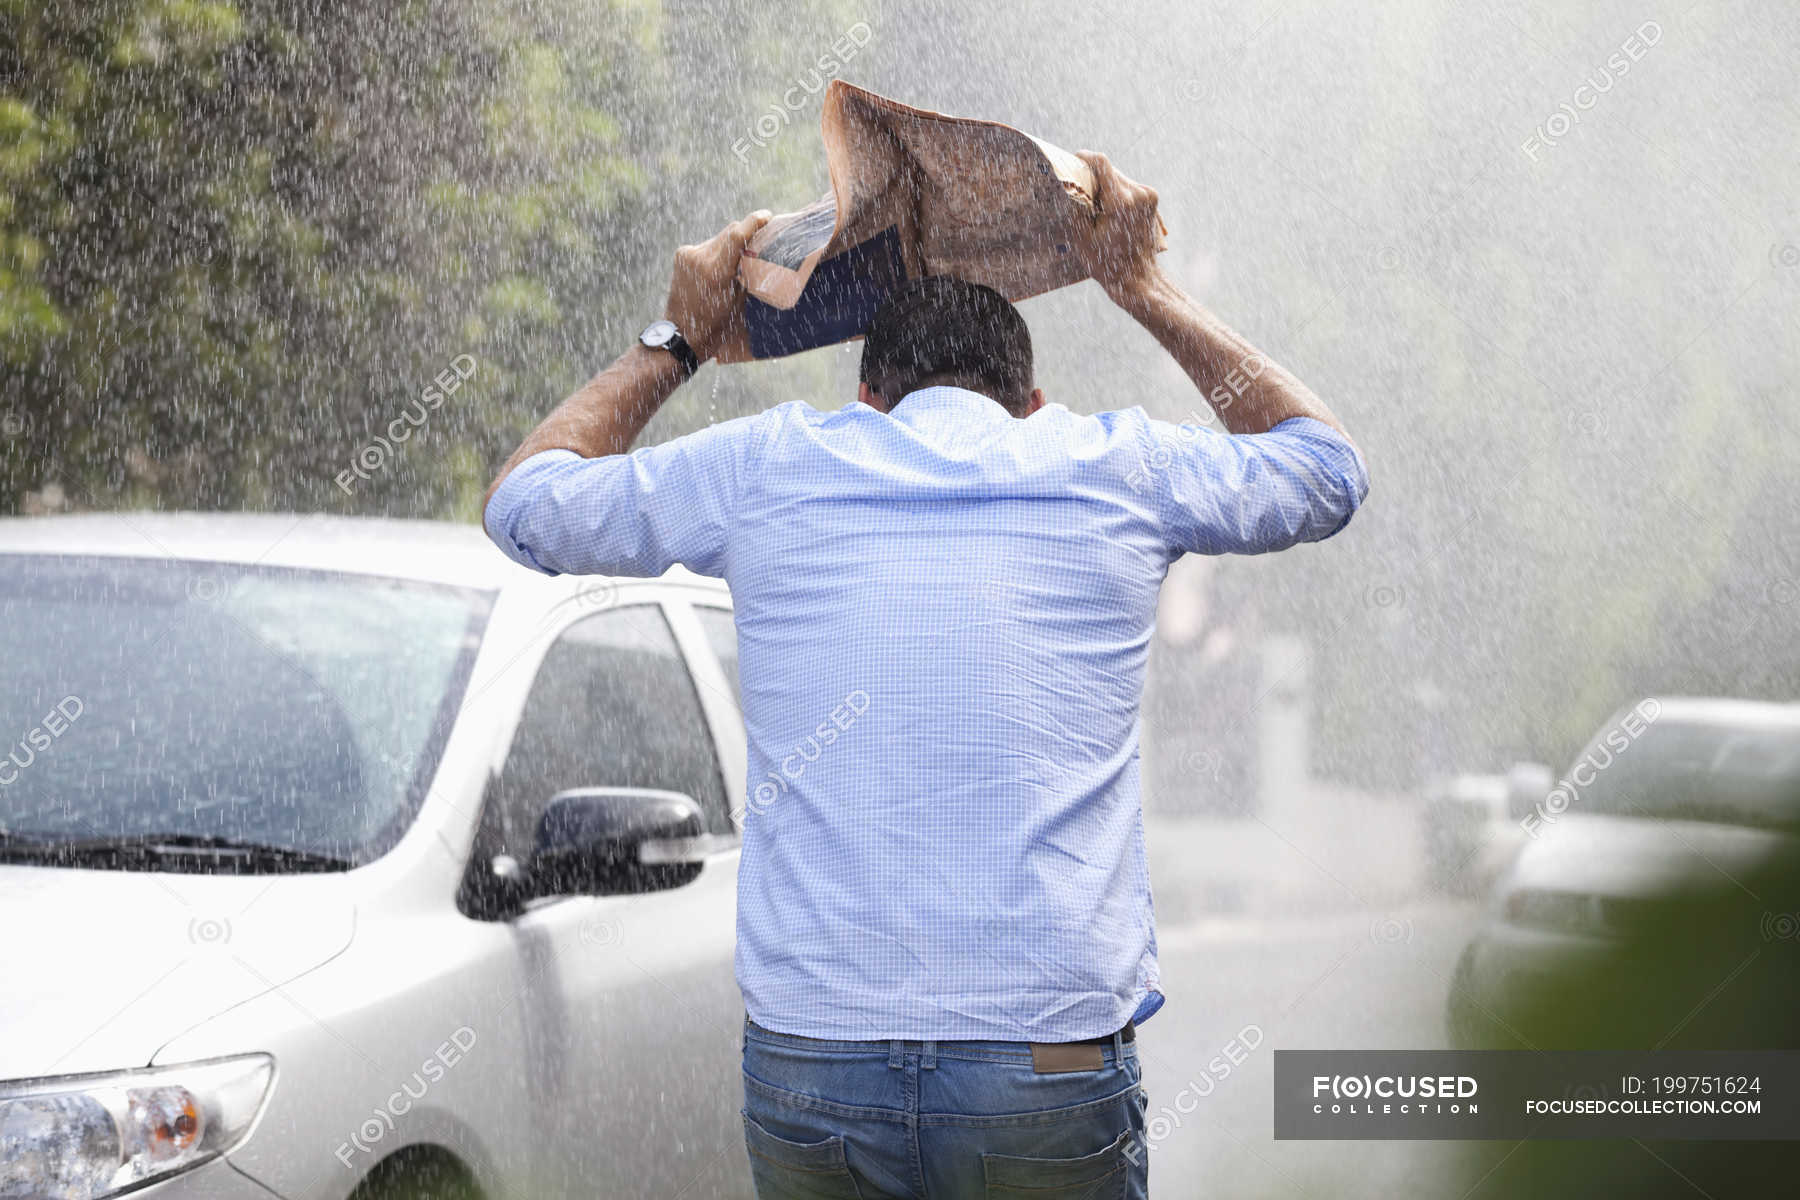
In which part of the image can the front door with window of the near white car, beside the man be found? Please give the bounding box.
[490,588,749,1196]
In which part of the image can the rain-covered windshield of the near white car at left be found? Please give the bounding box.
[0,556,490,871]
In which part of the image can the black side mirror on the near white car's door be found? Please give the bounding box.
[527,788,706,896]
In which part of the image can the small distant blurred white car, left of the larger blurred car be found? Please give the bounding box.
[1420,763,1555,896]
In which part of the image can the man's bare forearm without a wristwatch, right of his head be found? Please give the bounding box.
[1109,268,1348,437]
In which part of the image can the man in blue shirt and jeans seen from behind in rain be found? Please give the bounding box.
[486,155,1368,1200]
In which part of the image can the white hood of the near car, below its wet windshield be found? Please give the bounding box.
[0,865,356,1079]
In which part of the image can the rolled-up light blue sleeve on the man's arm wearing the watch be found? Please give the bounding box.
[482,414,769,578]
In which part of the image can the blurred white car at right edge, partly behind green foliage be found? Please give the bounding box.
[1449,700,1800,1049]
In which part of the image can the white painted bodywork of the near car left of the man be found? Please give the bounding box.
[0,515,749,1200]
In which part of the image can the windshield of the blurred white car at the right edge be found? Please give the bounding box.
[1577,721,1800,833]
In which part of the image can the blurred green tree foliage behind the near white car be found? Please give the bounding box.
[0,0,871,518]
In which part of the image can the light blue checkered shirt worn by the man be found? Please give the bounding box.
[486,387,1368,1042]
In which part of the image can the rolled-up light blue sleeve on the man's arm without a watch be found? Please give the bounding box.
[1143,417,1368,554]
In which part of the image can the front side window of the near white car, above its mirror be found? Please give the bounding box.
[495,604,731,845]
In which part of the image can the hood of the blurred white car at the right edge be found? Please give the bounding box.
[1501,813,1800,896]
